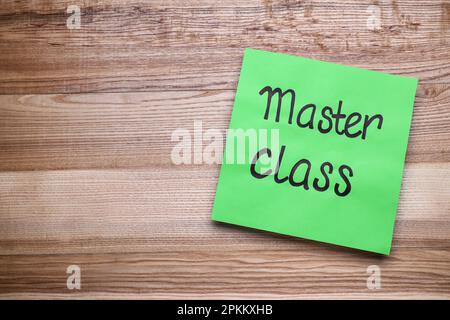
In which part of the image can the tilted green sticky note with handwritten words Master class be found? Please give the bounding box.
[212,49,417,254]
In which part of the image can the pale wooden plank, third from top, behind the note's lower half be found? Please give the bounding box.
[0,163,450,255]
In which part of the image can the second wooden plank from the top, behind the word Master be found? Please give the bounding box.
[0,85,450,171]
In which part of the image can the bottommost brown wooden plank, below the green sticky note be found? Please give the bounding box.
[0,246,450,299]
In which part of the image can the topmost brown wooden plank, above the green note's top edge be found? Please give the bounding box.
[0,0,450,94]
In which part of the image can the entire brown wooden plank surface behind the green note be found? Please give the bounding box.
[0,0,450,298]
